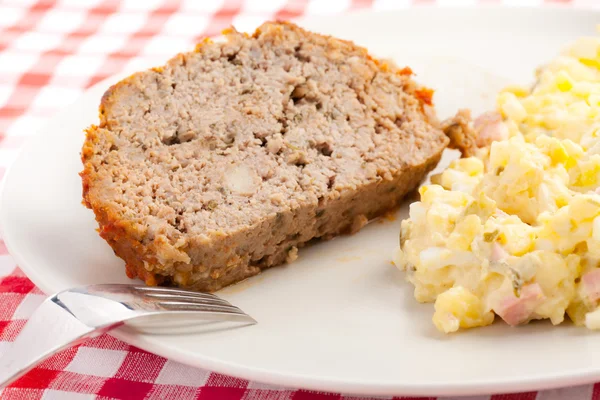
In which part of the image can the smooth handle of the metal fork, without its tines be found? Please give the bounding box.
[0,300,118,388]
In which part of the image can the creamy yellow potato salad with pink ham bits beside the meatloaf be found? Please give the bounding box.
[394,33,600,333]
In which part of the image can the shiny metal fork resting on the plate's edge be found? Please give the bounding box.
[0,284,256,387]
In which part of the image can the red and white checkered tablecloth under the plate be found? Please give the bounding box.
[0,0,600,400]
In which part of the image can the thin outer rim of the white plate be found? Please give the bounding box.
[0,4,600,396]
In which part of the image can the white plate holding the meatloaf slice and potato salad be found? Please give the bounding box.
[0,8,600,395]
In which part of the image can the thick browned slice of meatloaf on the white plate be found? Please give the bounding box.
[81,23,448,291]
